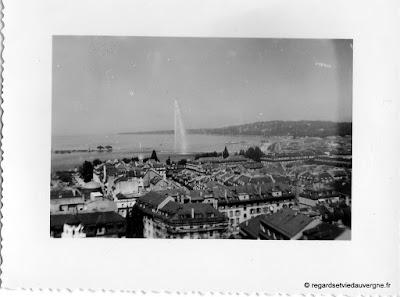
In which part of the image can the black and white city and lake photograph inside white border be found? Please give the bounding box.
[49,35,353,240]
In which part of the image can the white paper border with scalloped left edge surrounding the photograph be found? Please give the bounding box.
[1,0,400,295]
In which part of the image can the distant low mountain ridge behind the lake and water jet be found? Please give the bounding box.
[120,121,352,137]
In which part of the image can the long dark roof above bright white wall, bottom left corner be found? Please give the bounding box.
[50,211,125,227]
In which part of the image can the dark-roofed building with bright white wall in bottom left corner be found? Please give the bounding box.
[50,211,126,238]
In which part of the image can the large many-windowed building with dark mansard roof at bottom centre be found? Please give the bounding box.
[134,192,228,239]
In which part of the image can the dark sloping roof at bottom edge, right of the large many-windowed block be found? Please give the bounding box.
[261,208,313,238]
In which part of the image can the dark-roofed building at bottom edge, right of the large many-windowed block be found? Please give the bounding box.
[259,209,321,240]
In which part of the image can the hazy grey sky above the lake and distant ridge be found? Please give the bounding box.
[52,36,353,135]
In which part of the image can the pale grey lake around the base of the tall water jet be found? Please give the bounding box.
[51,134,271,171]
